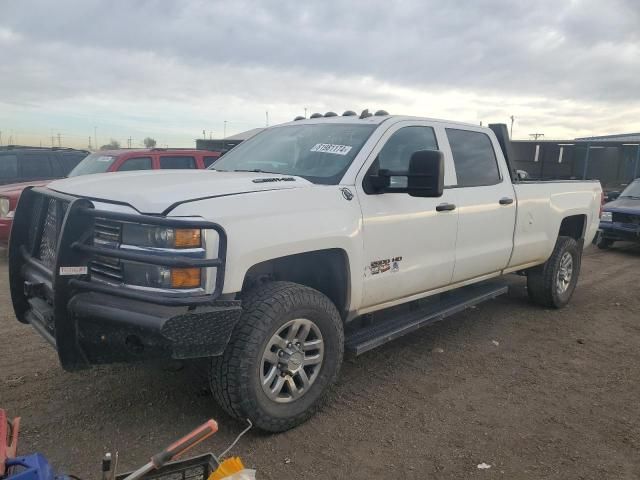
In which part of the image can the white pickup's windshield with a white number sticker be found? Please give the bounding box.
[211,123,376,185]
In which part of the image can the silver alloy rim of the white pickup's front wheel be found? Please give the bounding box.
[260,318,324,403]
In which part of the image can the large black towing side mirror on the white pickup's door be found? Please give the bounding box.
[365,150,444,197]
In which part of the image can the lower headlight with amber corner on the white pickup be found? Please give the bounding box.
[122,262,202,289]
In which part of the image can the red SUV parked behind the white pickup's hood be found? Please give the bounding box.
[0,148,220,246]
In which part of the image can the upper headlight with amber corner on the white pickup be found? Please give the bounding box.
[122,223,202,248]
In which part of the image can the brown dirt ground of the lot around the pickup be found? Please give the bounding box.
[0,246,640,480]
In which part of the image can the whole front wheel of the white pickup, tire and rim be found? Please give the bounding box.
[210,282,344,432]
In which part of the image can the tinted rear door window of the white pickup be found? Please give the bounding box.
[446,128,501,187]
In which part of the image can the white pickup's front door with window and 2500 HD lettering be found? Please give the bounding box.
[356,122,458,308]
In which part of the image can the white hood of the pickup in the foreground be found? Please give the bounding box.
[49,170,313,214]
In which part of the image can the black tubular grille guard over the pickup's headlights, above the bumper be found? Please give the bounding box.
[9,188,227,318]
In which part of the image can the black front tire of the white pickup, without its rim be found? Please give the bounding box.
[210,282,344,432]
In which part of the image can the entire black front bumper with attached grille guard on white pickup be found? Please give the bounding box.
[9,189,241,370]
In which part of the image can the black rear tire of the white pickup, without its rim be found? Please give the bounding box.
[527,237,582,308]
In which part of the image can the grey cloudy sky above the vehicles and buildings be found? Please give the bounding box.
[0,0,640,147]
